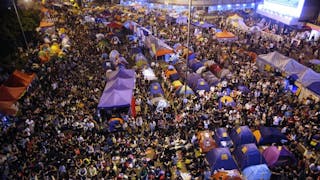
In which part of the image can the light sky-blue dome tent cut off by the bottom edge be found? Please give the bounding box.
[242,164,271,180]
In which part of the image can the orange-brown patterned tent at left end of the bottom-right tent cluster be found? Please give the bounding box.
[197,131,217,153]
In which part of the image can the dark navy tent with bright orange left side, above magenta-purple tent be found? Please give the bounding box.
[253,126,288,145]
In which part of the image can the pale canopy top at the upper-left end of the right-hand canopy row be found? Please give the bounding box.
[257,51,294,71]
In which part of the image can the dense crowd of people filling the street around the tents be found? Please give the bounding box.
[0,1,320,179]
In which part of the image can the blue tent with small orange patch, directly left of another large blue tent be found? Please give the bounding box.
[206,148,238,172]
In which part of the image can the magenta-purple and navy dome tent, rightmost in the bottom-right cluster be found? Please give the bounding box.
[262,146,296,167]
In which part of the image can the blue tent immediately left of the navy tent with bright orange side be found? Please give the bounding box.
[230,126,256,147]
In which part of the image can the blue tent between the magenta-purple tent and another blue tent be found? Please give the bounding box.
[234,143,266,170]
